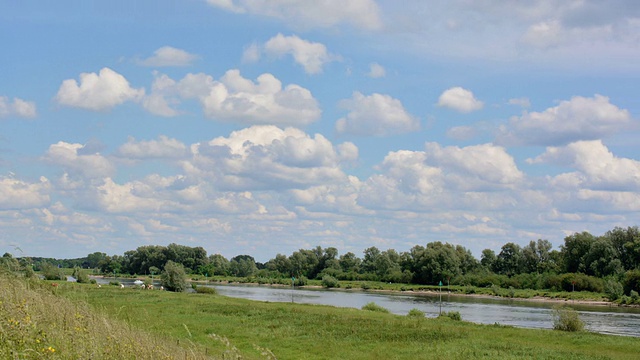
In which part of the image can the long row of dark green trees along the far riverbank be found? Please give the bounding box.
[13,226,640,293]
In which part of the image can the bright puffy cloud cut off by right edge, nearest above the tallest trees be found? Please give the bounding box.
[527,140,640,191]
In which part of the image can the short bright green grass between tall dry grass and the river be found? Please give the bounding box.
[65,285,640,359]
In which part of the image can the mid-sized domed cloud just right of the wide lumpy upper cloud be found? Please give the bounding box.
[336,92,420,136]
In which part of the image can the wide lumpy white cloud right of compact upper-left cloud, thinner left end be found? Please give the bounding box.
[143,70,321,126]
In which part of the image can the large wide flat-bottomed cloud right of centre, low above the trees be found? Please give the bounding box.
[359,143,524,212]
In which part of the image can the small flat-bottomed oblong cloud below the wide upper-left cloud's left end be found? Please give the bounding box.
[116,135,188,159]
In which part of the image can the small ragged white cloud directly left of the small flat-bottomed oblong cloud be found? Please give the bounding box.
[44,141,115,179]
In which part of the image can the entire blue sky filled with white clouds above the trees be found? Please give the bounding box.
[0,0,640,262]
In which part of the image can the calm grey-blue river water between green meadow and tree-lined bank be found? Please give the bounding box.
[214,285,640,337]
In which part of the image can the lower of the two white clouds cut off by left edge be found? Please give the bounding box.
[0,177,51,210]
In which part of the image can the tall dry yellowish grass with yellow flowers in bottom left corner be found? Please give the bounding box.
[0,274,215,359]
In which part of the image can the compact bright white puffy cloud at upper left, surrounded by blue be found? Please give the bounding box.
[55,67,144,111]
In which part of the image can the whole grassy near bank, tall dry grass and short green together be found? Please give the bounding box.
[0,277,640,359]
